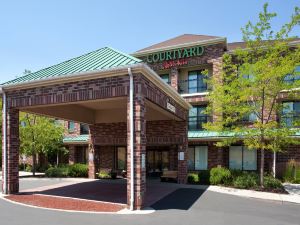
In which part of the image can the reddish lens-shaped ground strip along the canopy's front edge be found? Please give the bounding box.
[5,194,126,212]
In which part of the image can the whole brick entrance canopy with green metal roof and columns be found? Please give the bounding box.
[2,45,191,209]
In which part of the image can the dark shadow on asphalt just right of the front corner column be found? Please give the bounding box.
[151,188,205,210]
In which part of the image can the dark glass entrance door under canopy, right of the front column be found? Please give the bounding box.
[147,150,169,176]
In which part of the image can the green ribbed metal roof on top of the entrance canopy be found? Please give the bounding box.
[2,47,141,85]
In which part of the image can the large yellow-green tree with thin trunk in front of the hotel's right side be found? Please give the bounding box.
[205,4,300,186]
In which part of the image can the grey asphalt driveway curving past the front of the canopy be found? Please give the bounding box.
[0,179,300,225]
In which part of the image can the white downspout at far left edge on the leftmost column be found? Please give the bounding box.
[1,88,7,194]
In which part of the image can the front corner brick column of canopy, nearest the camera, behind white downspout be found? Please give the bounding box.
[127,81,146,209]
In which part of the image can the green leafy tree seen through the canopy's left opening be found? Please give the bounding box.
[20,113,65,175]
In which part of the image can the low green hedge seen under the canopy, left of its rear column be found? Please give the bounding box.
[45,164,88,177]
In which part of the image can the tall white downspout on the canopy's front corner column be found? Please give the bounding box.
[128,68,134,211]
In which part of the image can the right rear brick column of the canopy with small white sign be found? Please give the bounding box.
[178,122,188,184]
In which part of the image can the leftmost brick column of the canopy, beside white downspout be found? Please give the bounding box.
[2,108,19,194]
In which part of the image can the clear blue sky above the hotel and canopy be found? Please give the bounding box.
[0,0,300,83]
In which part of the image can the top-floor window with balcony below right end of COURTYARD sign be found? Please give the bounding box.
[188,70,207,94]
